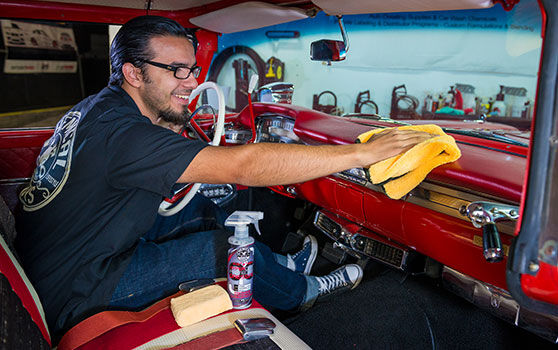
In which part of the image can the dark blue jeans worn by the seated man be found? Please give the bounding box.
[109,195,307,310]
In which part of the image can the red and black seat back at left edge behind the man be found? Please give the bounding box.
[0,196,51,349]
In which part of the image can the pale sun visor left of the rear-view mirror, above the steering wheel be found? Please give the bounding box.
[190,1,308,33]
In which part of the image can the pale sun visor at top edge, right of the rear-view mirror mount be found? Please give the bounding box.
[312,0,494,15]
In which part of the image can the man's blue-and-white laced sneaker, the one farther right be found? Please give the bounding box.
[316,264,363,301]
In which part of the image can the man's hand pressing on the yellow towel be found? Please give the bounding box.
[361,129,436,167]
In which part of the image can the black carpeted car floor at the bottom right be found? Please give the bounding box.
[283,270,556,349]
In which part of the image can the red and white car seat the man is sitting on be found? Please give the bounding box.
[0,196,309,350]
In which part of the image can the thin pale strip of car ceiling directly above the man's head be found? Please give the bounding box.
[37,0,224,11]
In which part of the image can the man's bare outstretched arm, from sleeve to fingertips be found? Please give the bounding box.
[178,129,432,186]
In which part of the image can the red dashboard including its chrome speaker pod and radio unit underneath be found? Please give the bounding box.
[243,104,525,288]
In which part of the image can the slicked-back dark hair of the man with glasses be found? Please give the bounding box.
[109,16,198,85]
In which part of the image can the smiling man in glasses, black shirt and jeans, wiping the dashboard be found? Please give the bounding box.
[14,16,429,339]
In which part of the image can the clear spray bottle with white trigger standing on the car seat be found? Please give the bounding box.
[225,210,263,309]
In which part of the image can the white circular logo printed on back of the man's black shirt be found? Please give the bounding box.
[19,111,81,211]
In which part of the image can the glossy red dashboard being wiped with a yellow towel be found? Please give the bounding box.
[237,103,527,289]
